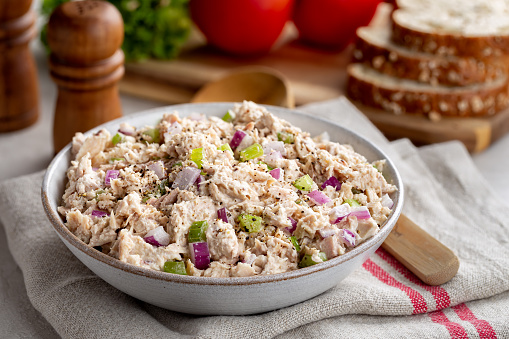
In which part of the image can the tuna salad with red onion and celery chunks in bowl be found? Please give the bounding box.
[58,102,396,277]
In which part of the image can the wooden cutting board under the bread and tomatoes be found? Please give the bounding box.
[120,11,509,152]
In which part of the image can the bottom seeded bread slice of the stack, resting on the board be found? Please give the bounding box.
[347,63,509,118]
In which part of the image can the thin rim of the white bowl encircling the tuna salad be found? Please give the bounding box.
[41,102,404,286]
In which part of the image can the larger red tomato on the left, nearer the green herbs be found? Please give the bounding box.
[189,0,294,54]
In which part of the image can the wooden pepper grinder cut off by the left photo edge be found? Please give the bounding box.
[0,0,39,132]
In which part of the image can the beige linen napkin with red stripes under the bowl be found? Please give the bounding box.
[0,98,509,339]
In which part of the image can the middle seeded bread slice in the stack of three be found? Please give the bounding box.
[353,26,507,86]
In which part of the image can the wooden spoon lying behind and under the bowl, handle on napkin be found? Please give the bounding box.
[191,67,459,285]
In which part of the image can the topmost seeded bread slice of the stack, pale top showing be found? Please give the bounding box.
[392,0,509,58]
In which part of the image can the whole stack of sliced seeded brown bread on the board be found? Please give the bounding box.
[347,0,509,120]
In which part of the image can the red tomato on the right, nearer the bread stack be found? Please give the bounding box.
[293,0,381,49]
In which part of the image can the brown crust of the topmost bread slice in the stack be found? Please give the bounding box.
[392,9,509,59]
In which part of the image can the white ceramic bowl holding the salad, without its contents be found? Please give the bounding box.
[42,103,403,315]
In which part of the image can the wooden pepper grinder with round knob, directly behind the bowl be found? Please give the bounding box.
[48,1,124,152]
